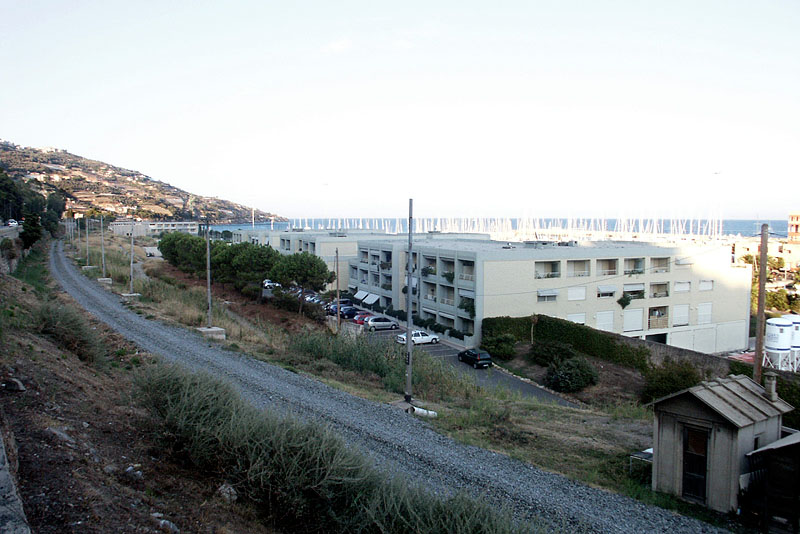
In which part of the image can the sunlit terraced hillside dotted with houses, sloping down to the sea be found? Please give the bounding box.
[0,140,286,224]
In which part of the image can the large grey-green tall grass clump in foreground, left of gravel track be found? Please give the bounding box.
[137,365,544,534]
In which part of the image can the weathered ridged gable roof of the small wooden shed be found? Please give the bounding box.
[653,375,794,428]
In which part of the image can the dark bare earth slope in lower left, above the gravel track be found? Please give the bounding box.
[0,270,276,534]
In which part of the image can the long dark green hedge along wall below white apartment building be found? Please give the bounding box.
[482,315,650,372]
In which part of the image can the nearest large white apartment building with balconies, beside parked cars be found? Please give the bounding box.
[348,239,751,353]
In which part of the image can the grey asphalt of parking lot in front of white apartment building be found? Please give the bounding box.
[367,325,575,406]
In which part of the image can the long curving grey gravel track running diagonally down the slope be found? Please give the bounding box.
[50,242,723,533]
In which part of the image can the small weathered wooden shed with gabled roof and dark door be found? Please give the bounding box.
[653,373,793,512]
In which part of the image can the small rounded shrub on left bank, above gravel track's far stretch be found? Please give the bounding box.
[34,302,105,361]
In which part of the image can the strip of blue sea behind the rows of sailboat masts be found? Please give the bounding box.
[211,217,789,239]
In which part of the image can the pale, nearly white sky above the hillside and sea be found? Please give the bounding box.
[0,0,800,219]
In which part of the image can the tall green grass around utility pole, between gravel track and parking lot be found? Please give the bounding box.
[289,332,477,400]
